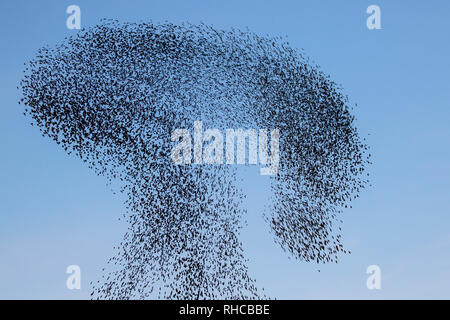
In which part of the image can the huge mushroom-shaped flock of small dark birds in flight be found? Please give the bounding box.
[20,20,369,299]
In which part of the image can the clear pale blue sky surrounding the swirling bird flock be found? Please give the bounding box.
[0,0,450,299]
